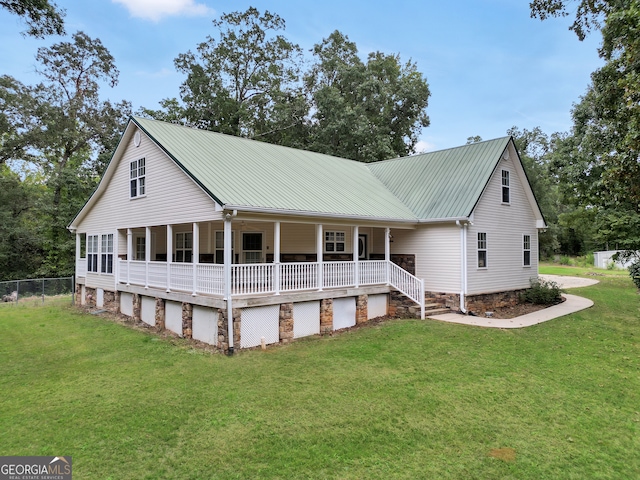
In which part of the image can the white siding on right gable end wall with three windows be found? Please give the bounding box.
[467,152,538,294]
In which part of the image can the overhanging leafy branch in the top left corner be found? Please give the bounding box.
[0,0,64,38]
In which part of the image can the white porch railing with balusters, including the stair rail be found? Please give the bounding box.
[116,260,424,316]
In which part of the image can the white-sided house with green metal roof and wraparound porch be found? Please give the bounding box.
[69,118,545,352]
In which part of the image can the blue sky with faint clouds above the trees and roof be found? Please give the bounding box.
[0,0,602,152]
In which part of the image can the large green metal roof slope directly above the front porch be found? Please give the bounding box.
[133,118,416,221]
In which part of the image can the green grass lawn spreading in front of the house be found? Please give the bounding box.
[0,267,640,480]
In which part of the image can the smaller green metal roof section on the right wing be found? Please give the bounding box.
[368,137,511,220]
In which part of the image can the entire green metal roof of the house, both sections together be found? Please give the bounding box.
[133,117,510,222]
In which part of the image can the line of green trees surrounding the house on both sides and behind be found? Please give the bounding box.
[0,0,640,280]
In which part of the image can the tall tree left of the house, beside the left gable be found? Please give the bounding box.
[0,32,130,275]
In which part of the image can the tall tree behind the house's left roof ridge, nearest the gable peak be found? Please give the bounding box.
[160,7,306,139]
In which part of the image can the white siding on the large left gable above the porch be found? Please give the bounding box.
[78,125,220,234]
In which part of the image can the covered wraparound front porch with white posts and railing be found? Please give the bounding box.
[77,217,424,316]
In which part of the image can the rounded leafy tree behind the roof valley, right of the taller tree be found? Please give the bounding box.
[305,31,430,162]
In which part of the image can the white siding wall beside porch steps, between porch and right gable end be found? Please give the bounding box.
[391,224,461,293]
